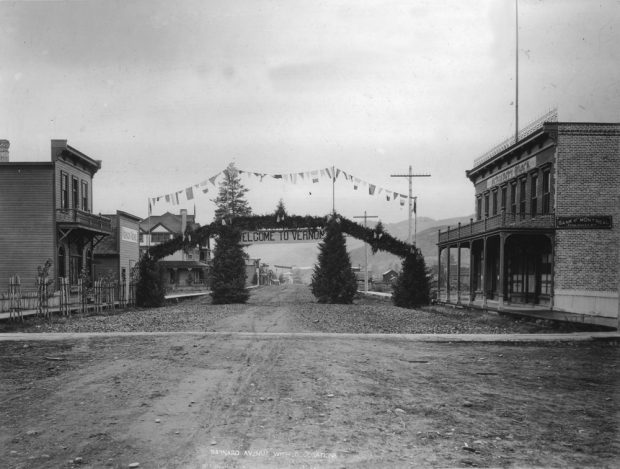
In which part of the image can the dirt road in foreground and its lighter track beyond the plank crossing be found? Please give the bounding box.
[0,289,620,468]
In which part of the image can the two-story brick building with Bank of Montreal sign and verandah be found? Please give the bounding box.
[438,114,620,327]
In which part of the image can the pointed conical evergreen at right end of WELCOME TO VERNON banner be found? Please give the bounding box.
[311,219,357,304]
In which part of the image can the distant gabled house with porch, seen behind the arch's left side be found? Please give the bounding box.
[139,209,210,289]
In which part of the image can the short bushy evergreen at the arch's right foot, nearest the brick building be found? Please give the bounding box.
[392,248,430,308]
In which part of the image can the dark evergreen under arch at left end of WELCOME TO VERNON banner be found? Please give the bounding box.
[211,226,250,304]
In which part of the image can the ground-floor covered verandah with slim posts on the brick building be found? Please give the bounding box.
[437,224,554,314]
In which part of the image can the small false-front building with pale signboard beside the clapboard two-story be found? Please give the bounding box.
[93,210,140,287]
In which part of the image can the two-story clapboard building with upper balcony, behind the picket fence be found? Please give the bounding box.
[0,140,111,285]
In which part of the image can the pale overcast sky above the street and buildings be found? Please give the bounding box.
[0,0,620,223]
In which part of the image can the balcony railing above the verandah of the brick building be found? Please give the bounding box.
[439,212,555,243]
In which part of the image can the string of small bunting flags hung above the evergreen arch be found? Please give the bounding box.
[148,162,417,213]
